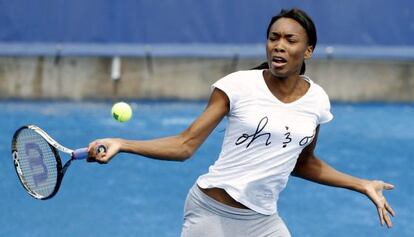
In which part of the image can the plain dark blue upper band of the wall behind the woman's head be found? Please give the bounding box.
[0,0,414,57]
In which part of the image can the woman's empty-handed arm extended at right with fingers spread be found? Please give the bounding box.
[292,126,395,228]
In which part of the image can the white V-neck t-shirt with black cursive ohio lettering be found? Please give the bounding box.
[197,70,333,215]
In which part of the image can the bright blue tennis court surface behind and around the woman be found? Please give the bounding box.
[0,101,414,237]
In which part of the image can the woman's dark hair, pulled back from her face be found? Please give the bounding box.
[252,8,318,75]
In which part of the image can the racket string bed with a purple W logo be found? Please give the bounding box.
[16,129,58,197]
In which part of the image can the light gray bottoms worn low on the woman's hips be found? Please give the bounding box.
[181,184,291,237]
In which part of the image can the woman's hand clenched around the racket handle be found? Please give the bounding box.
[88,138,121,164]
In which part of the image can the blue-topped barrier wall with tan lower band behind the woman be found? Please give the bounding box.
[0,0,414,101]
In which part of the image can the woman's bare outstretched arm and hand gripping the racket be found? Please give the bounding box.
[88,89,229,163]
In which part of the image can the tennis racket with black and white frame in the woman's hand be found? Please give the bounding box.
[12,125,106,200]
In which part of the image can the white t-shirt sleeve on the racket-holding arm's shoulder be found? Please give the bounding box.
[211,72,240,113]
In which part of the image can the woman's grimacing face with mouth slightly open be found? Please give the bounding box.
[266,18,313,77]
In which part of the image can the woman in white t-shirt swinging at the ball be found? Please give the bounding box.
[89,9,394,237]
